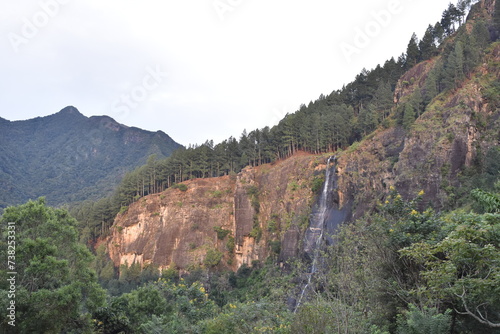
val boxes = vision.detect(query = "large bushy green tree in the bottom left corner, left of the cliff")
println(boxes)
[0,199,104,333]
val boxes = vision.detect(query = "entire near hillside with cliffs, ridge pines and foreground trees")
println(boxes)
[0,0,500,334]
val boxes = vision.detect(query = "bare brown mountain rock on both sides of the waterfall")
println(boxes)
[106,1,500,270]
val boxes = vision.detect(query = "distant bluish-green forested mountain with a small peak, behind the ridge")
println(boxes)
[0,106,181,208]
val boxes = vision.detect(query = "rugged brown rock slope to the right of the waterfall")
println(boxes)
[338,43,500,218]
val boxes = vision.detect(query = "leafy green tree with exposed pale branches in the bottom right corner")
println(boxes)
[401,213,500,327]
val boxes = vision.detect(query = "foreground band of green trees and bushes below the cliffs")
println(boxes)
[0,182,500,334]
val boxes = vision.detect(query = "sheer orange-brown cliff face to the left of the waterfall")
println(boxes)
[106,154,325,269]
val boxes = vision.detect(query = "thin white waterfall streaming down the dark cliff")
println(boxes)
[294,156,335,313]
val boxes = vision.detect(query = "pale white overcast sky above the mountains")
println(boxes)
[0,0,455,146]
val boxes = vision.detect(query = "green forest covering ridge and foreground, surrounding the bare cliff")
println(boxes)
[0,0,500,334]
